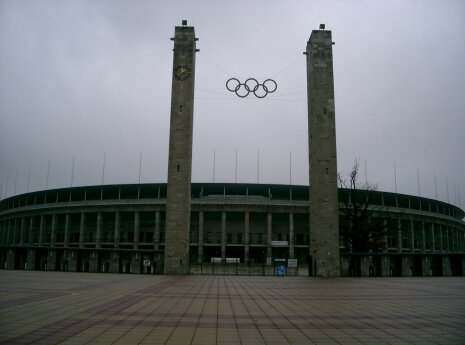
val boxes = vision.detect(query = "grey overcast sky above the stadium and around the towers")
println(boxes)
[0,0,465,208]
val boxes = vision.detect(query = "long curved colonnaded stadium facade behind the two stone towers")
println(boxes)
[0,183,465,276]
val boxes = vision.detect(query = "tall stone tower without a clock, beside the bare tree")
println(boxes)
[305,24,340,277]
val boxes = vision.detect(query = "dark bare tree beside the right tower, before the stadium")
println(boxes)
[338,159,389,253]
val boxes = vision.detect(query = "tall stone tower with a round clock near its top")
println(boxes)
[164,20,197,274]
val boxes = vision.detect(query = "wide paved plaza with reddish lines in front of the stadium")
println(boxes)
[0,271,465,345]
